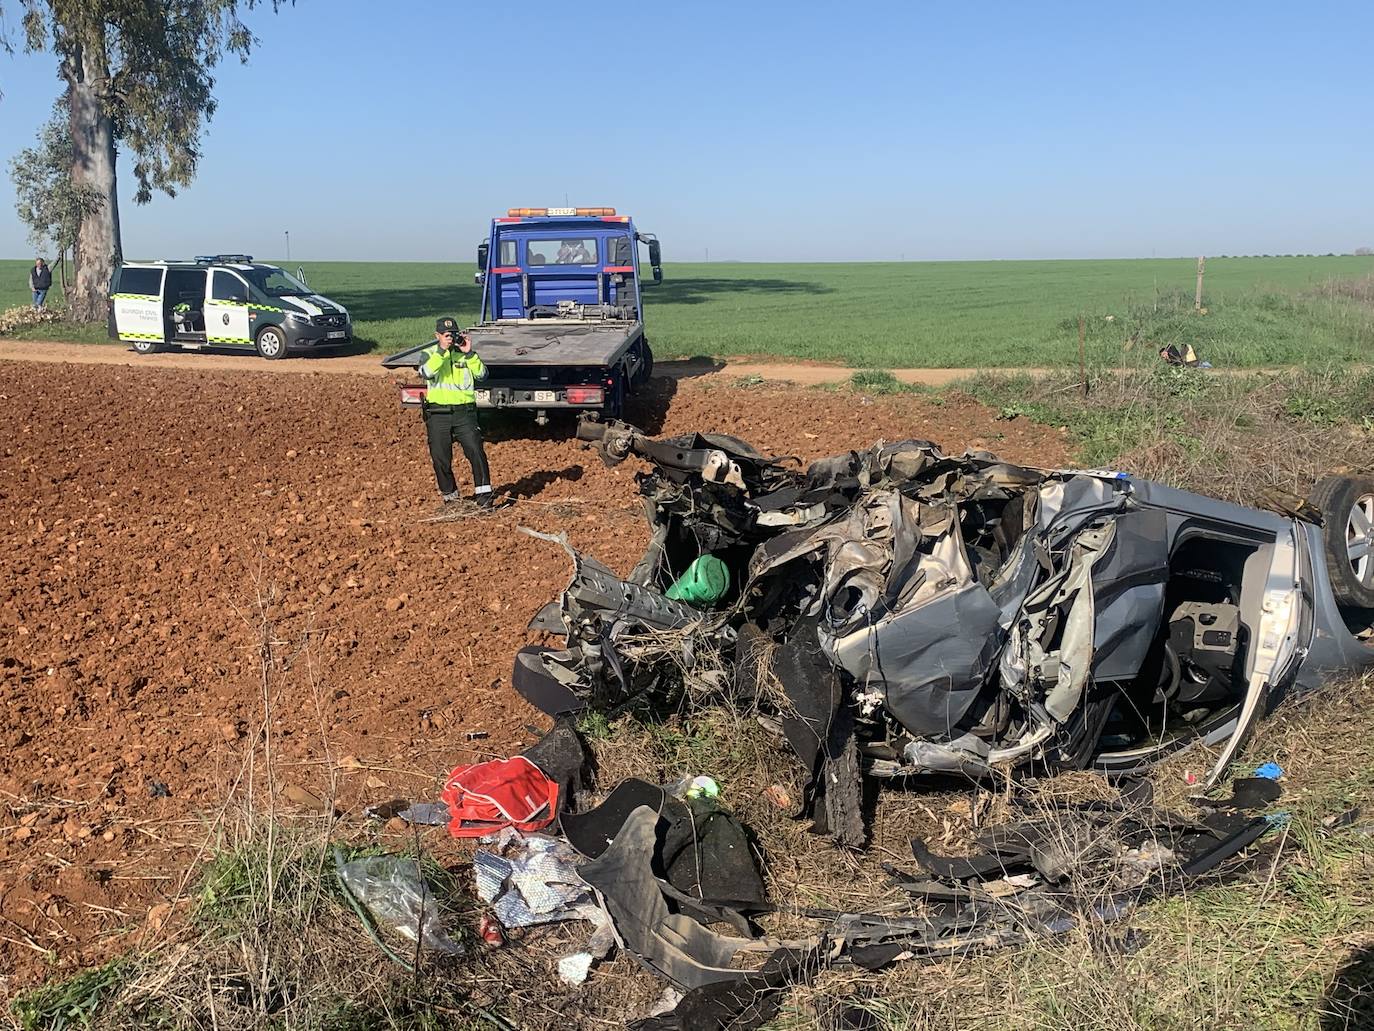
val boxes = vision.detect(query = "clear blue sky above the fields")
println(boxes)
[0,0,1374,263]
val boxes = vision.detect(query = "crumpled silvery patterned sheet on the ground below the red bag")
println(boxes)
[473,828,600,928]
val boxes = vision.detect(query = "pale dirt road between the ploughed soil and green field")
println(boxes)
[0,340,1011,386]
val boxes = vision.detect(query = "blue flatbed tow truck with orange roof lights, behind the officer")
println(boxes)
[382,208,664,426]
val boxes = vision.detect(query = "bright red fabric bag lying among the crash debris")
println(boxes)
[441,755,558,837]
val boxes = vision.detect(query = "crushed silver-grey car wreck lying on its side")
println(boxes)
[513,421,1374,839]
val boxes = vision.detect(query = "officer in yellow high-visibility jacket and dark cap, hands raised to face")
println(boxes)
[420,316,492,509]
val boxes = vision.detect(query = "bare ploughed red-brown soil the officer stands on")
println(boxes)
[0,362,1066,994]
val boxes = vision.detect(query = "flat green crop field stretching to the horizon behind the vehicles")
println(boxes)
[0,257,1374,368]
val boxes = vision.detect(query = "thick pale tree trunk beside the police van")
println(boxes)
[63,40,124,322]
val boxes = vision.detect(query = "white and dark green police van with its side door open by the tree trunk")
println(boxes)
[109,254,353,359]
